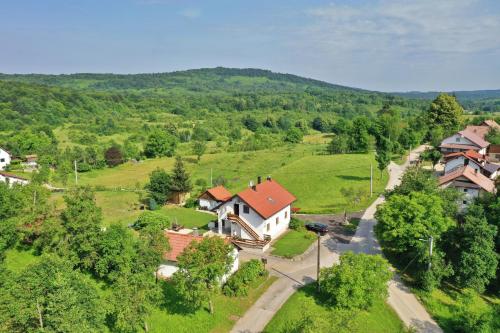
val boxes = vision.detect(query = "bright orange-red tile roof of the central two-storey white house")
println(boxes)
[237,179,297,219]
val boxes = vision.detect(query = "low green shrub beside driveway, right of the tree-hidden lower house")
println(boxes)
[223,259,268,296]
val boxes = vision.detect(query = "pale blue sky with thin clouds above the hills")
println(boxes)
[0,0,500,91]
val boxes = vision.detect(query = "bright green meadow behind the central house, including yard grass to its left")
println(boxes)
[65,136,387,226]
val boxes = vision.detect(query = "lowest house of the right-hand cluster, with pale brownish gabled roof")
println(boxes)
[439,166,495,209]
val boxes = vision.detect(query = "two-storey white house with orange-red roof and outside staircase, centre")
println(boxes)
[215,177,296,249]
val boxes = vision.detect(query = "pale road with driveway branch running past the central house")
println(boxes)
[231,147,442,333]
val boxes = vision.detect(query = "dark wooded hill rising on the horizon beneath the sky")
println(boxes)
[0,67,363,93]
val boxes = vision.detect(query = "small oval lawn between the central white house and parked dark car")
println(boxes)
[271,229,317,258]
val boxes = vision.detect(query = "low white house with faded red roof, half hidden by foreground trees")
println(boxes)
[157,229,239,282]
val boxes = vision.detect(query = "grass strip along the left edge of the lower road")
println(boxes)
[148,276,277,333]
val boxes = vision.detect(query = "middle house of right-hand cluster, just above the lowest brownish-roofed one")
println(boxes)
[444,150,500,179]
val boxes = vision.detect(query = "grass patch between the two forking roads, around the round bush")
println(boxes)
[264,284,404,333]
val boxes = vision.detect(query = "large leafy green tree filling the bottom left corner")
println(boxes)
[0,255,105,333]
